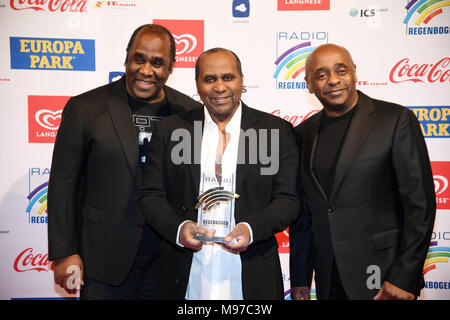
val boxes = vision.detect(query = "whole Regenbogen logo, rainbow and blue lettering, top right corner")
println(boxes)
[403,0,450,36]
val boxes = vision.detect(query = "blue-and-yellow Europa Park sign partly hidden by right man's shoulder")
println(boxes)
[408,106,450,138]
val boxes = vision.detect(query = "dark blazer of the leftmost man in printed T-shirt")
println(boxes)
[48,77,201,285]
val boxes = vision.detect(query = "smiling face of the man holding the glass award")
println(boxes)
[196,50,244,123]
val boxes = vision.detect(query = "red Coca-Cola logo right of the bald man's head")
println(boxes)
[389,57,450,83]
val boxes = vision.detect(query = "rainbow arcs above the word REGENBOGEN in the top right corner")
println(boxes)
[403,0,450,25]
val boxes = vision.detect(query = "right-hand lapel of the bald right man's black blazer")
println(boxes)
[331,91,376,199]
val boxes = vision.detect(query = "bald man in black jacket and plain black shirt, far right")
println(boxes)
[290,44,436,299]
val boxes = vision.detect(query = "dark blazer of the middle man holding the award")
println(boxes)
[139,104,298,299]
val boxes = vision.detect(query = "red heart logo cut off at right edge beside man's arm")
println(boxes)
[431,161,450,210]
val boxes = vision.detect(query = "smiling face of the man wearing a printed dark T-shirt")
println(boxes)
[125,30,173,102]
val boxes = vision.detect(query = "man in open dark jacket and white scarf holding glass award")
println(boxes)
[139,48,298,299]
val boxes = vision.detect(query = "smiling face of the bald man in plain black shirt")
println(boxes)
[305,44,358,117]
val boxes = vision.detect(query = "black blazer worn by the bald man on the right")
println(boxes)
[291,91,436,299]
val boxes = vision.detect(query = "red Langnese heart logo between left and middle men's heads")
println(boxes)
[153,19,205,68]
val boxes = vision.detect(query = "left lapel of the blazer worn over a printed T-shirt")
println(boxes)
[106,78,139,176]
